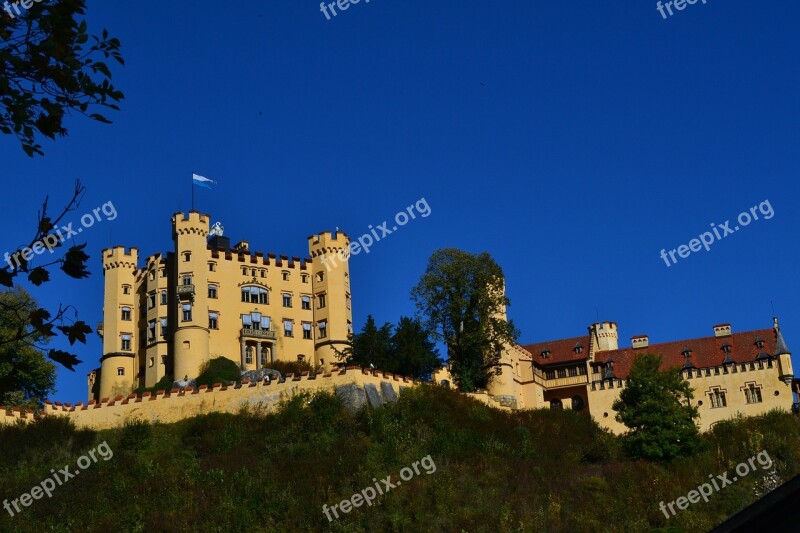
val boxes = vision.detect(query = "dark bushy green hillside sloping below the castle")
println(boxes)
[0,386,800,532]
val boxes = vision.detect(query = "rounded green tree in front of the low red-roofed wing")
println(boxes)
[612,353,700,462]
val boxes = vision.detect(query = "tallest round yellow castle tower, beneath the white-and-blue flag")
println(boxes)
[170,211,209,380]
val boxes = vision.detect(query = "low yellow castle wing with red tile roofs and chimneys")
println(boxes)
[466,318,794,433]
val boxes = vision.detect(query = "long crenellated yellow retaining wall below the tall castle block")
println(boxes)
[0,367,418,430]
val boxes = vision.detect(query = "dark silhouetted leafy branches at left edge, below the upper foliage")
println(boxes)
[0,181,92,371]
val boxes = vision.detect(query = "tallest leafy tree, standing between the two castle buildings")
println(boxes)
[411,248,519,392]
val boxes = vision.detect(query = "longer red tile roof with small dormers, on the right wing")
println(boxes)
[595,328,777,379]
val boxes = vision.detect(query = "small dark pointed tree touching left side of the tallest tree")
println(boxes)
[386,316,442,379]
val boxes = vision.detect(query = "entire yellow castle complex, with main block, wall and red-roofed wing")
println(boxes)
[0,211,788,433]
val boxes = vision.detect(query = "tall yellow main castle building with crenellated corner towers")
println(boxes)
[89,211,352,400]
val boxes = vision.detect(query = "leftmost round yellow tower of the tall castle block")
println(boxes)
[98,246,139,399]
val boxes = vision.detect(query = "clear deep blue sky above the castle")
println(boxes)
[0,0,800,401]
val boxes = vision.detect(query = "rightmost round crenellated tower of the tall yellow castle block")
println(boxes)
[308,231,353,370]
